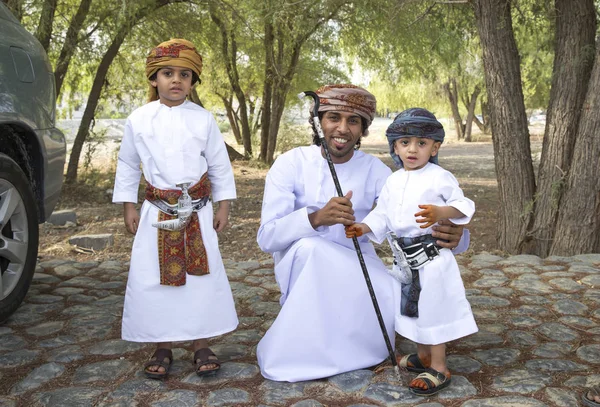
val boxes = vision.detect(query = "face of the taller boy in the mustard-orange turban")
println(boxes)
[150,66,192,107]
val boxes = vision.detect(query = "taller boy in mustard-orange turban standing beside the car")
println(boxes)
[113,39,238,379]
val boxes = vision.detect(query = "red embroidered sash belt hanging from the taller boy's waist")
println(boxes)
[145,173,211,286]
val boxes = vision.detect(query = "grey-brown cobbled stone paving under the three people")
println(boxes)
[0,253,600,407]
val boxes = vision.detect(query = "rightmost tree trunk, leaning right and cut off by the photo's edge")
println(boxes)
[550,39,600,256]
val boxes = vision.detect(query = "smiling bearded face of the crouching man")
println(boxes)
[321,111,363,164]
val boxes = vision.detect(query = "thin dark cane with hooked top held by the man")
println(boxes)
[298,91,400,377]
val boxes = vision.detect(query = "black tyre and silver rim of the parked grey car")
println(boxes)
[0,154,39,322]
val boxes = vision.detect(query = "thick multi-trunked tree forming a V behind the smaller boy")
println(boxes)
[473,0,600,256]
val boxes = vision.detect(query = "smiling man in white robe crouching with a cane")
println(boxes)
[257,85,462,382]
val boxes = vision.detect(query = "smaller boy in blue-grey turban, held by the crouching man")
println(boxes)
[346,108,477,396]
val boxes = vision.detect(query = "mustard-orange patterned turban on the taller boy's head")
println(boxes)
[146,38,202,100]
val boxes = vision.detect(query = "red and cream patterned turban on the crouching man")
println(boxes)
[310,84,377,135]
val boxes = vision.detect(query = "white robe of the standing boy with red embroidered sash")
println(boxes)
[113,101,238,342]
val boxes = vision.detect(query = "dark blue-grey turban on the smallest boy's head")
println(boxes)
[385,107,445,167]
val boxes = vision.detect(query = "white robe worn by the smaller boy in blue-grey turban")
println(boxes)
[363,163,477,345]
